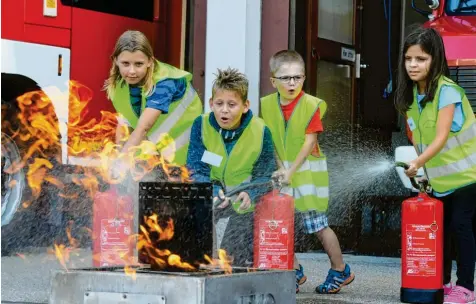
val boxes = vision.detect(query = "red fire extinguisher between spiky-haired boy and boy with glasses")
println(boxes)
[253,190,294,269]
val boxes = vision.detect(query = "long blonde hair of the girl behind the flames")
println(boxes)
[103,31,158,99]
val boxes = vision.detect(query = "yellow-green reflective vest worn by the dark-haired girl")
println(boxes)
[407,77,476,192]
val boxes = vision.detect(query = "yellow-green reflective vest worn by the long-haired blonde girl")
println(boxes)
[112,61,202,165]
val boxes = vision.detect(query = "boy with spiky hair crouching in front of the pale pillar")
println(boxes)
[187,68,277,266]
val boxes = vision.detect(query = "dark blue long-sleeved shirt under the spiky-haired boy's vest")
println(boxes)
[187,110,277,203]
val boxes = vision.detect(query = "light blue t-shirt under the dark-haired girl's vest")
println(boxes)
[417,85,465,197]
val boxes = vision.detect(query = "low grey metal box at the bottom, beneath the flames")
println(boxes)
[49,268,296,304]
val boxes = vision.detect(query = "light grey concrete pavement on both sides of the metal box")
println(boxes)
[1,250,468,304]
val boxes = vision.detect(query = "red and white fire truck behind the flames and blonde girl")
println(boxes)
[1,0,185,252]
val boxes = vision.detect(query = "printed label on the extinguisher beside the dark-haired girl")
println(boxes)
[405,225,436,277]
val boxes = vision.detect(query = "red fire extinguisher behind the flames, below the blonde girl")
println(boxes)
[92,186,135,267]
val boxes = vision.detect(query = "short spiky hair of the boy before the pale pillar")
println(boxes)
[212,68,248,102]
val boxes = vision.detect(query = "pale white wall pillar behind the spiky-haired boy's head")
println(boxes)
[204,0,261,113]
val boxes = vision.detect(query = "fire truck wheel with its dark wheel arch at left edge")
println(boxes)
[1,73,61,256]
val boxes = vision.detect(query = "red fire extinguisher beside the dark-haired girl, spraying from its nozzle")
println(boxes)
[397,163,444,304]
